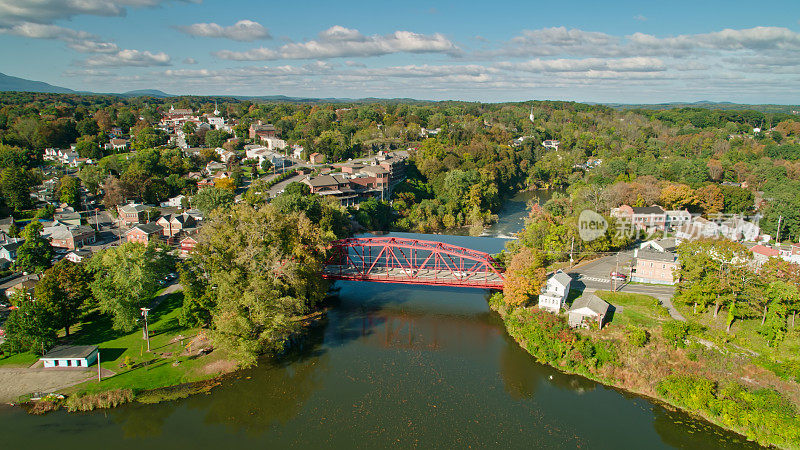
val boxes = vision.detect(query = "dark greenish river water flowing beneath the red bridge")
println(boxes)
[0,193,752,450]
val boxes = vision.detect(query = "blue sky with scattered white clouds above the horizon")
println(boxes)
[0,0,800,104]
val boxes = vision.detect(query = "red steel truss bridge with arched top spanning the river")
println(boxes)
[322,237,505,289]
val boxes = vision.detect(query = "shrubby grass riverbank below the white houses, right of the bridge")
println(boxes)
[491,292,800,448]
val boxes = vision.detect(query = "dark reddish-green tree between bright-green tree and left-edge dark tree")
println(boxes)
[35,259,91,336]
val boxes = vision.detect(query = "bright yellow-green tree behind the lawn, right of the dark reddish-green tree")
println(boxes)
[87,240,174,331]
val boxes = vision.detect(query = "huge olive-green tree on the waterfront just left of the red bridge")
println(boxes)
[193,203,327,366]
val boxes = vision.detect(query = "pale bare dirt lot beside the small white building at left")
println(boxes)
[0,366,97,403]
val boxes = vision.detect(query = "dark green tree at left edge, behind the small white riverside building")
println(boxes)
[3,291,57,355]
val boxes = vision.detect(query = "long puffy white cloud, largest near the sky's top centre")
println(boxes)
[215,25,461,61]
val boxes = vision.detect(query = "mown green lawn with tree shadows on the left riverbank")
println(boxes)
[0,292,237,410]
